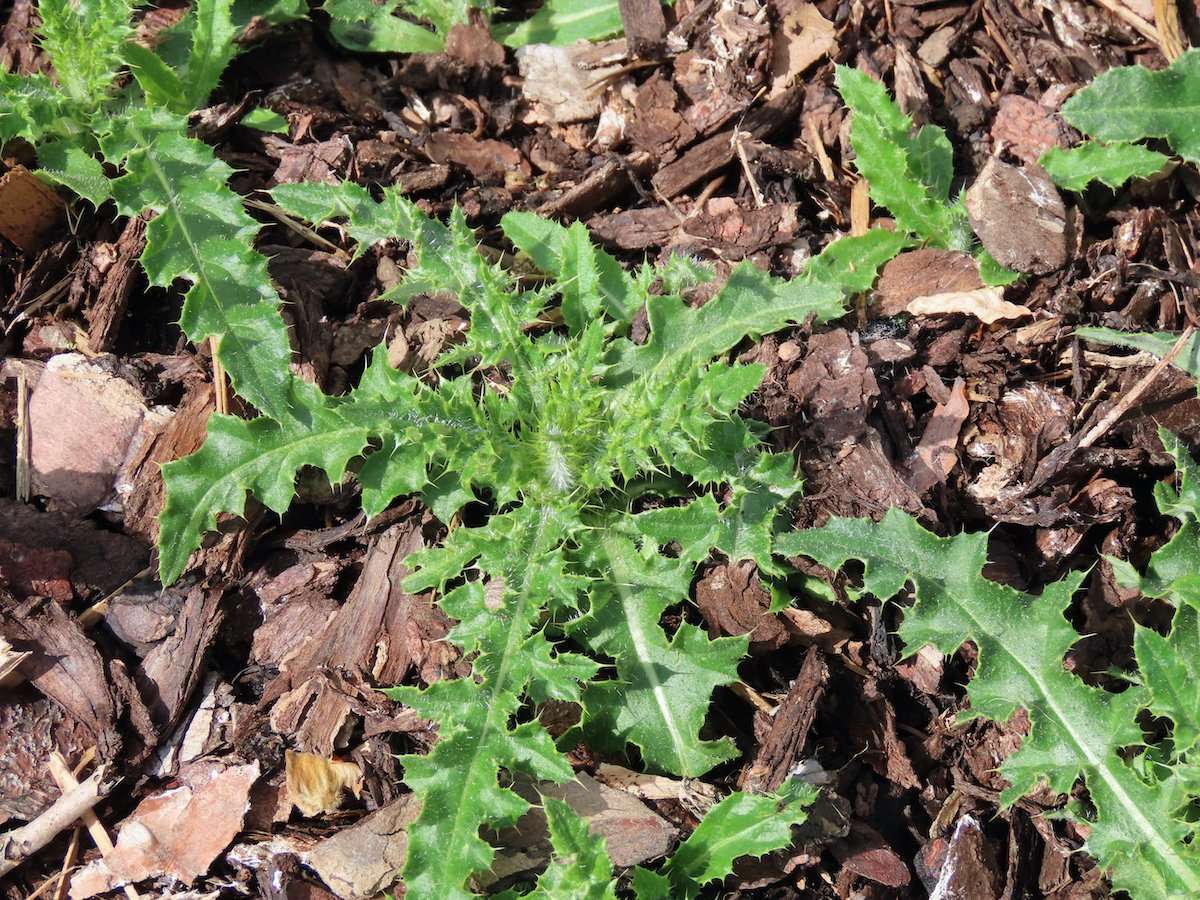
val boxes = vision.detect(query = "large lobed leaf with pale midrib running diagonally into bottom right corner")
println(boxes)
[776,509,1200,898]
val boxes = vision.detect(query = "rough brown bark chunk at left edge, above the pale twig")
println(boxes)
[0,596,121,761]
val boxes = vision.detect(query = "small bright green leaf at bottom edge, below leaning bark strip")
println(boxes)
[662,785,816,900]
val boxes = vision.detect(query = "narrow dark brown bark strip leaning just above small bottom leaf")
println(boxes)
[738,646,829,793]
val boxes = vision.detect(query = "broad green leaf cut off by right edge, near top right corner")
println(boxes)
[1062,49,1200,162]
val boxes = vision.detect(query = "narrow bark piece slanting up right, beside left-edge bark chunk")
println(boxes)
[134,586,223,733]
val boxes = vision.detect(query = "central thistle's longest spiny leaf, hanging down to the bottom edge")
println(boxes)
[388,505,594,898]
